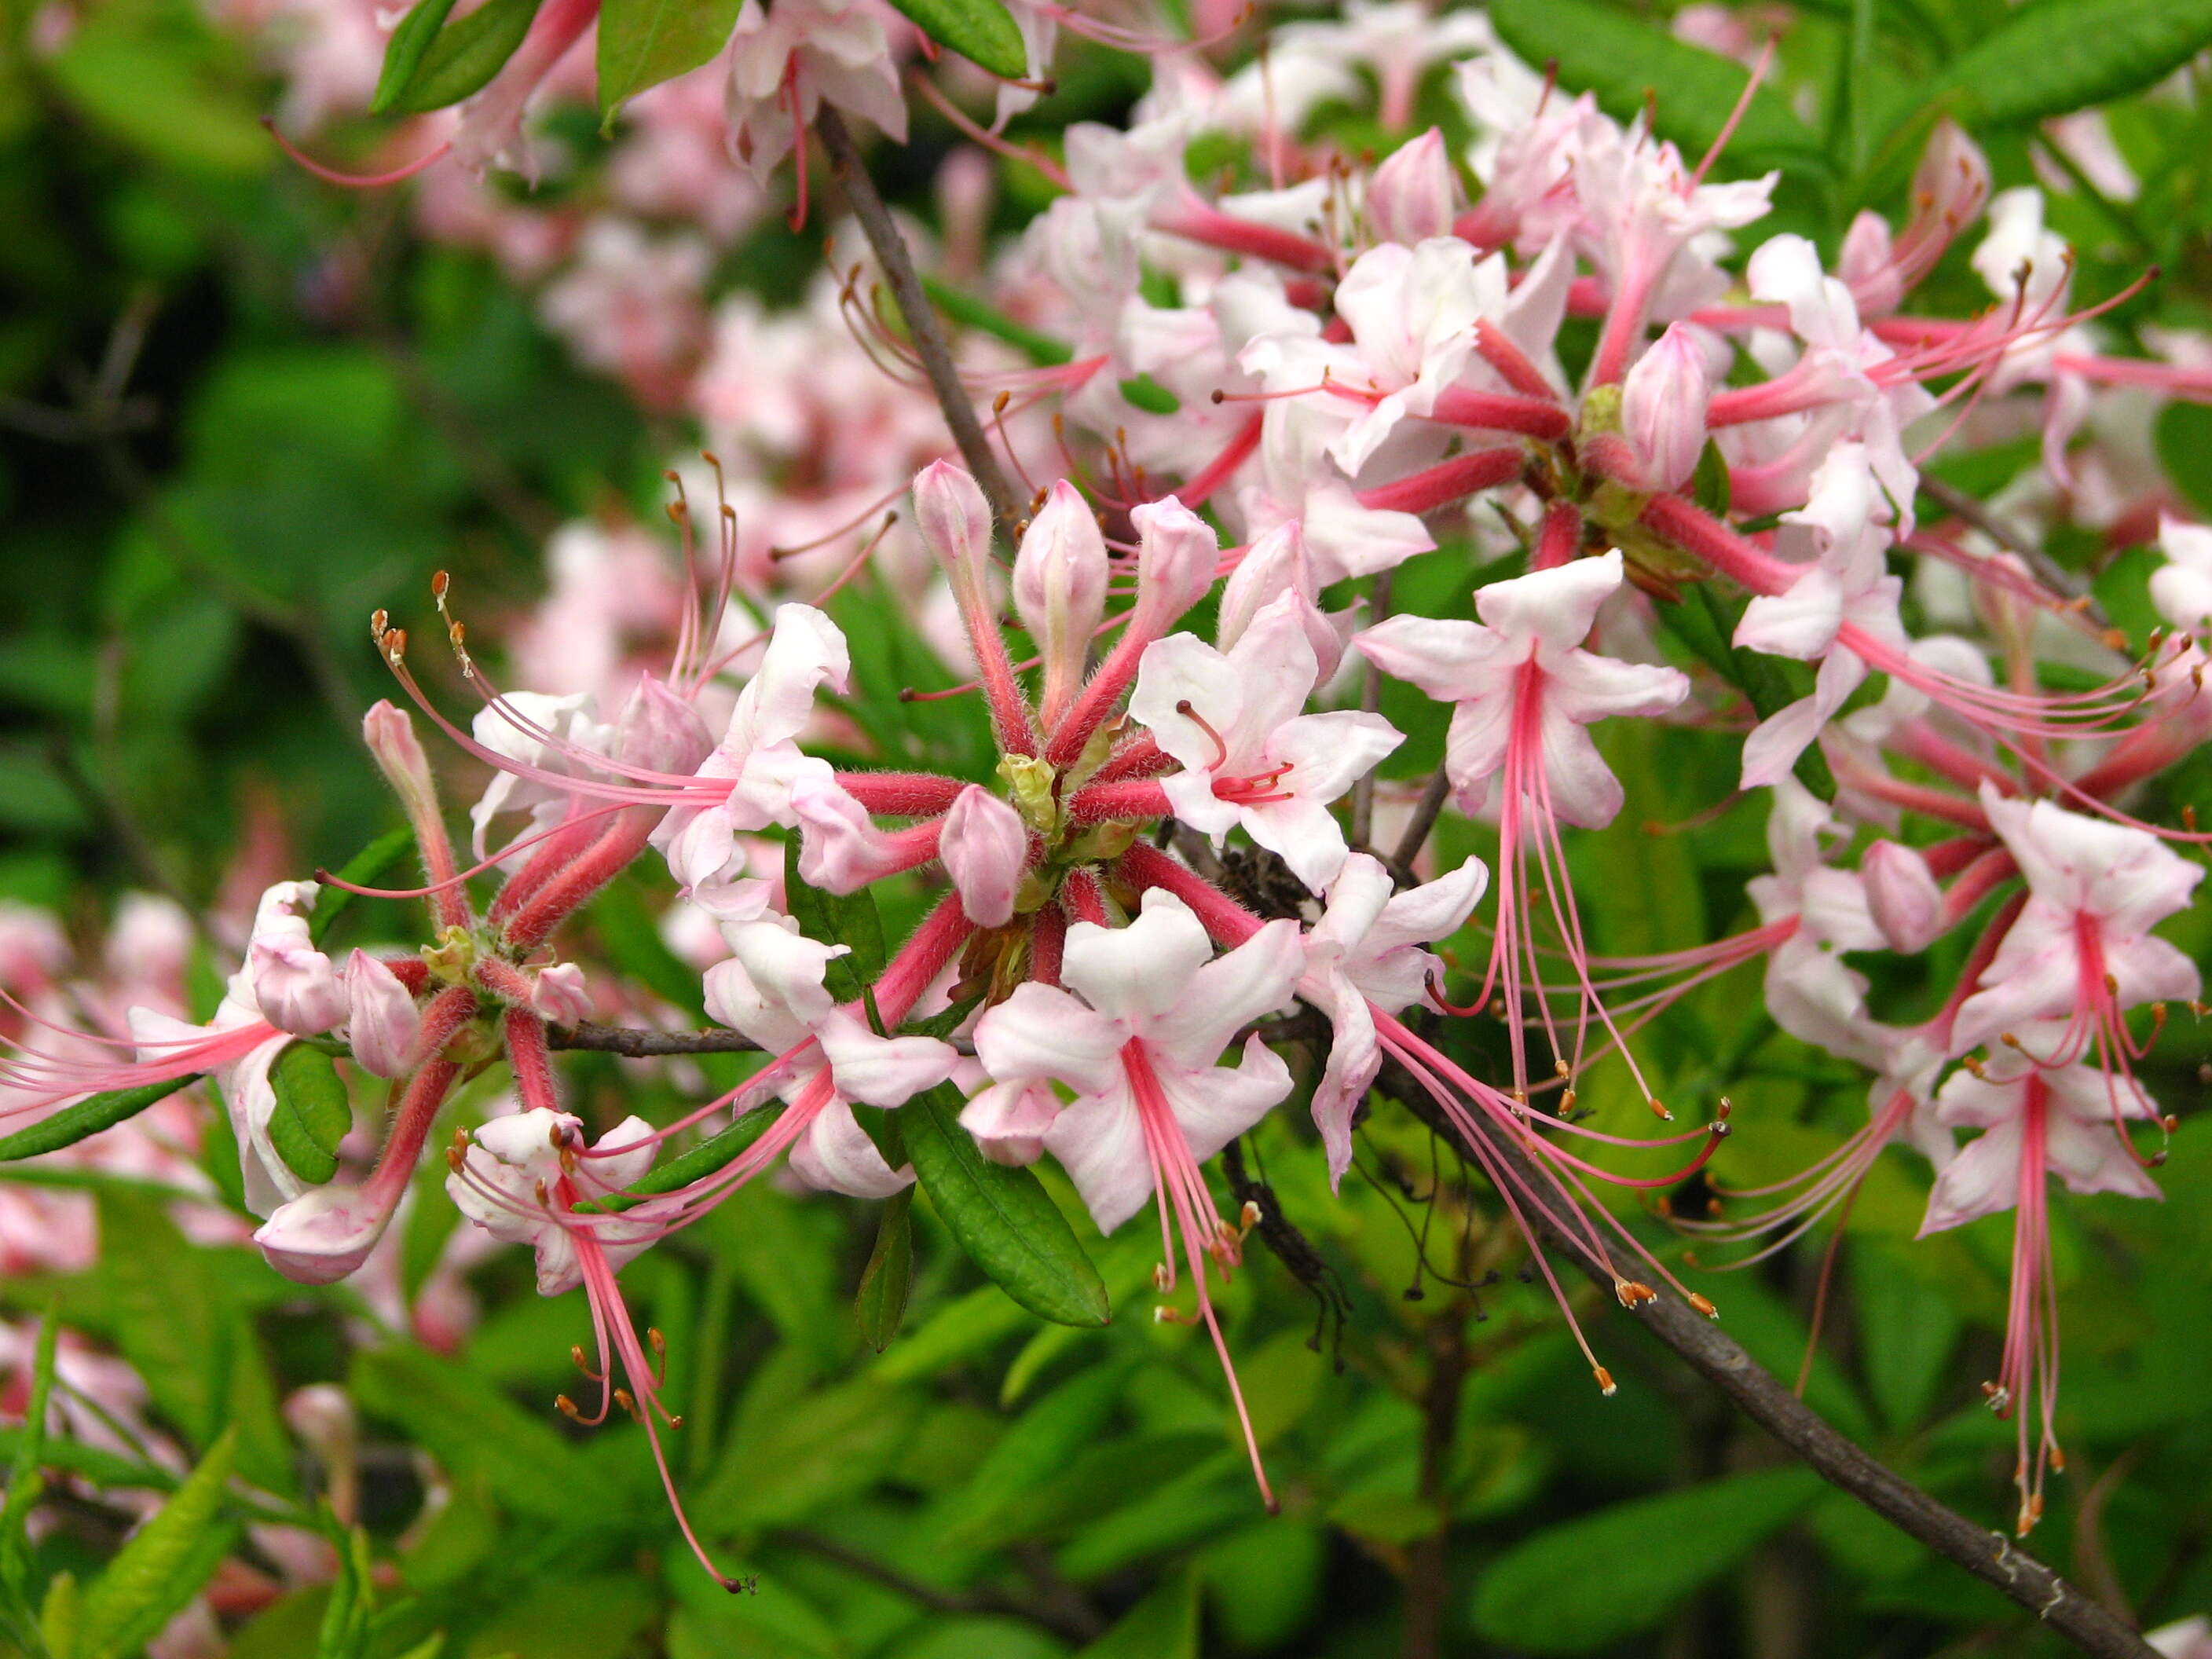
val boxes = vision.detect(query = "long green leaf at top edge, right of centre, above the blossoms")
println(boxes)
[1489,0,1829,174]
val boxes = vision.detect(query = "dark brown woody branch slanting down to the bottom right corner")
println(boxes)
[1376,1066,2157,1659]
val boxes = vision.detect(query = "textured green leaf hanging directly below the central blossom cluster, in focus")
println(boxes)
[898,1084,1112,1325]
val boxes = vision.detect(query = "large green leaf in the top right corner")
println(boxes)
[1916,0,2212,124]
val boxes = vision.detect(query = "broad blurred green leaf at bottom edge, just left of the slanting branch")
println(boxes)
[1473,1469,1821,1653]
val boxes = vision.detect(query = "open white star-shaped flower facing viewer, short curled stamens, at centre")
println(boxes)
[1128,593,1404,892]
